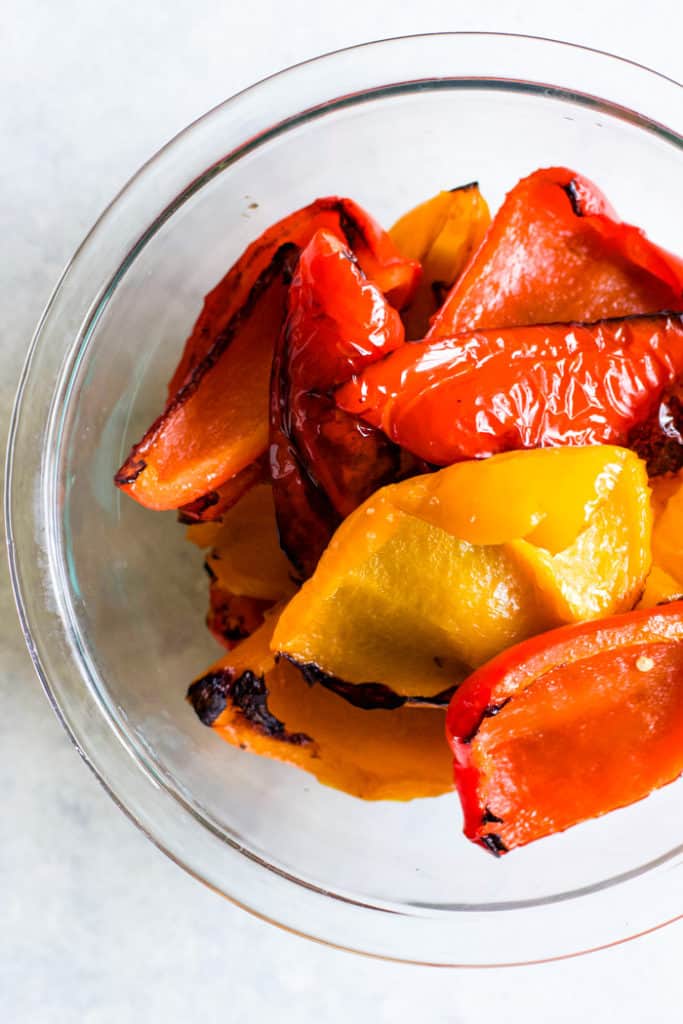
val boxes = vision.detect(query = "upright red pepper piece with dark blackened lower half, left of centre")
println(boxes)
[270,230,403,575]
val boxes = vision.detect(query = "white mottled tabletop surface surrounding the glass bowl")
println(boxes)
[0,0,683,1024]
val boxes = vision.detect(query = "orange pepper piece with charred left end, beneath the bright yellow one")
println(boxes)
[187,612,453,800]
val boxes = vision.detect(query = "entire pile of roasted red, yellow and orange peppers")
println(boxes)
[116,167,683,854]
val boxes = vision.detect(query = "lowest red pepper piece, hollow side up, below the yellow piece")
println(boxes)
[446,601,683,855]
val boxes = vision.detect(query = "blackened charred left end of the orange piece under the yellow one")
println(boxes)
[186,669,313,746]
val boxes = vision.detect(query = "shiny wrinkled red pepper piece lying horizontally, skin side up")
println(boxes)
[337,313,683,465]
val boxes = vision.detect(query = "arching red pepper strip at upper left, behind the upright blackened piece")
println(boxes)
[169,196,420,399]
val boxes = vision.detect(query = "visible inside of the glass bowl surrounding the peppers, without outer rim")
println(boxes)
[57,81,683,911]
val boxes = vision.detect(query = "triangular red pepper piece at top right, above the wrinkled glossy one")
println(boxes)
[428,167,683,340]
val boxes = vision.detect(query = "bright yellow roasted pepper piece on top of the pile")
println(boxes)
[272,446,651,707]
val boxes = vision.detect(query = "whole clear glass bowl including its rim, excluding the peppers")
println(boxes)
[7,34,683,965]
